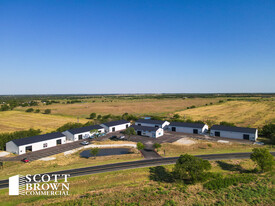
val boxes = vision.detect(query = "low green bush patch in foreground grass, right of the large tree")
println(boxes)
[203,174,257,190]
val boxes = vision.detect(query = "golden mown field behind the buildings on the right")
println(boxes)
[177,101,275,127]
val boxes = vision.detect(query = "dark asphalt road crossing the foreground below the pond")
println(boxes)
[0,152,275,189]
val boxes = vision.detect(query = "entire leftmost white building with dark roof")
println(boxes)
[6,132,66,155]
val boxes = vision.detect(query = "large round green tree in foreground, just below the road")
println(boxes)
[173,154,211,183]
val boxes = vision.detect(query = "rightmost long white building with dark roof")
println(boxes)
[210,125,258,141]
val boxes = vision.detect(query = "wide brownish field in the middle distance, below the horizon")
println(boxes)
[18,98,224,118]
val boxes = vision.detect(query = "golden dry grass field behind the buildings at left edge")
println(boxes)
[0,111,88,133]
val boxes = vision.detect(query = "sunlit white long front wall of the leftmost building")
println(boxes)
[15,136,66,154]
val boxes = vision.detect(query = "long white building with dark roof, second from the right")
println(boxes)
[168,122,208,134]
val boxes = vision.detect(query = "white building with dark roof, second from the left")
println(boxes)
[62,125,104,141]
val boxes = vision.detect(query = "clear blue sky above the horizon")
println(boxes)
[0,0,275,94]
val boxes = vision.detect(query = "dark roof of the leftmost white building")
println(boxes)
[12,132,65,146]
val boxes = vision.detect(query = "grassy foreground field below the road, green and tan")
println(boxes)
[0,160,274,206]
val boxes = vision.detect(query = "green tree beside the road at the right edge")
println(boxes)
[250,148,275,172]
